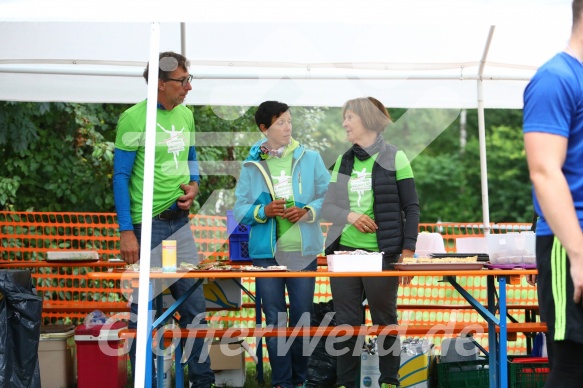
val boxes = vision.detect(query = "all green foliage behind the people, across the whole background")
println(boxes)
[0,102,532,222]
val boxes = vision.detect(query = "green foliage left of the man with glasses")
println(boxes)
[0,102,124,211]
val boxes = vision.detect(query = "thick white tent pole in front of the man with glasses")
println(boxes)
[134,23,160,387]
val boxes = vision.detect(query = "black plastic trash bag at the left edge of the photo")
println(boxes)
[0,270,42,388]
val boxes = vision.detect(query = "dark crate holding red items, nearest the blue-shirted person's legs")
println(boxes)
[508,357,550,388]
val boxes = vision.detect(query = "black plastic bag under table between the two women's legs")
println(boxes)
[306,300,336,387]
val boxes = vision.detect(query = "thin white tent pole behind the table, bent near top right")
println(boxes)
[478,26,496,235]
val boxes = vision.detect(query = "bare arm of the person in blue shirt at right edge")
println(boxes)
[524,132,583,302]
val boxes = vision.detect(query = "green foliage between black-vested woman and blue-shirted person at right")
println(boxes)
[411,110,532,222]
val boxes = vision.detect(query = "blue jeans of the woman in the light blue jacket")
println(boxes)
[253,252,317,388]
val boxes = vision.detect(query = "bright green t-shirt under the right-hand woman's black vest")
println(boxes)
[332,150,413,252]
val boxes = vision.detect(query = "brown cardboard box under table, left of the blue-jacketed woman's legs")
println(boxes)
[209,342,247,387]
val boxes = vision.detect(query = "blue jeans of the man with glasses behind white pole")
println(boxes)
[128,217,215,388]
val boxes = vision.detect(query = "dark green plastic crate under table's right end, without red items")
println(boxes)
[437,359,490,388]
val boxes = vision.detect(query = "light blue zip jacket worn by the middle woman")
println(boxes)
[233,139,330,259]
